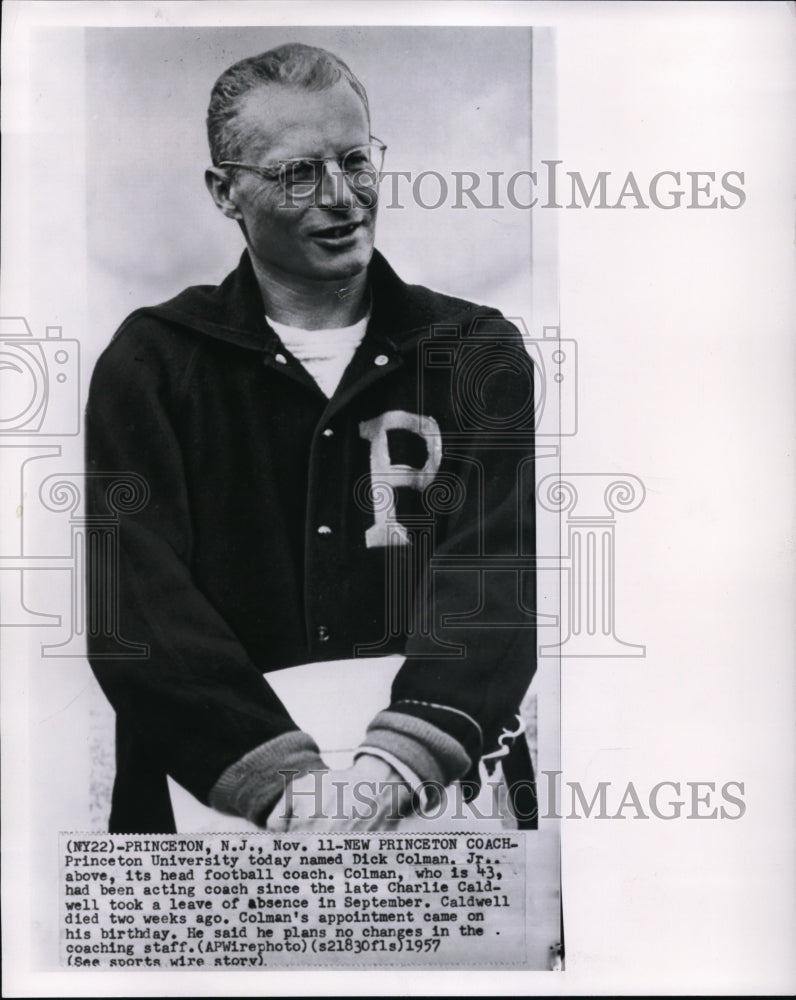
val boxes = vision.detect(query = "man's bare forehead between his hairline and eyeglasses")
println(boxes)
[237,80,369,157]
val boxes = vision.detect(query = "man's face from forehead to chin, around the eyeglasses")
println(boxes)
[231,81,376,281]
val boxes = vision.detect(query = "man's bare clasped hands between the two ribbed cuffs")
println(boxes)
[266,754,412,833]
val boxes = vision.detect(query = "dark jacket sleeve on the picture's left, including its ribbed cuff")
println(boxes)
[86,321,322,822]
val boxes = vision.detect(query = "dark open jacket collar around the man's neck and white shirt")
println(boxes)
[141,250,477,350]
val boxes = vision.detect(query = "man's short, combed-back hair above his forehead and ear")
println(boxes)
[207,42,370,166]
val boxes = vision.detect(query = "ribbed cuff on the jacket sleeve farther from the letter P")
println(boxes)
[209,730,326,825]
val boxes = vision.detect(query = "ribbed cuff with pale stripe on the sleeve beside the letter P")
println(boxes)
[364,711,470,787]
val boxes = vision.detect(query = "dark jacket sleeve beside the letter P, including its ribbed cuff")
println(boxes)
[365,314,536,785]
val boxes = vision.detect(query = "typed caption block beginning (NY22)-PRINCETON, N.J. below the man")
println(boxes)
[60,833,526,970]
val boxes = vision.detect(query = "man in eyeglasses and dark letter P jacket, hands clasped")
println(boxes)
[87,45,534,832]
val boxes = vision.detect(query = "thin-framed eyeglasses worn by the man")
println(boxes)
[218,135,387,198]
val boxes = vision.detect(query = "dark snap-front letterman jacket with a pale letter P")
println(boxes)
[86,246,535,832]
